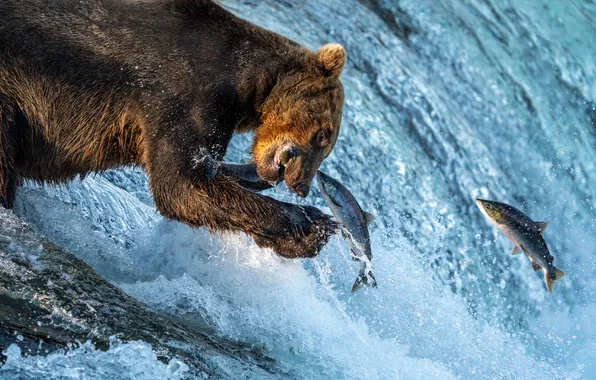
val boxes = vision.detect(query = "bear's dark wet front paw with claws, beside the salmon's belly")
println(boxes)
[255,204,338,258]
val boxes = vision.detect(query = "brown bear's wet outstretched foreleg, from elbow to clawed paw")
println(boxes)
[148,143,337,258]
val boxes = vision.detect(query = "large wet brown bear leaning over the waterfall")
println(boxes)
[0,0,346,257]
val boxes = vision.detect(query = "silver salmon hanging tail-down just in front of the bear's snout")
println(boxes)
[317,170,377,292]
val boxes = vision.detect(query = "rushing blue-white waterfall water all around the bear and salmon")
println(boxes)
[2,0,596,379]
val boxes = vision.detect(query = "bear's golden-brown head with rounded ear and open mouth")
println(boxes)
[252,44,346,197]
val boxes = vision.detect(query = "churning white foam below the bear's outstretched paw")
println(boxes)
[120,227,559,379]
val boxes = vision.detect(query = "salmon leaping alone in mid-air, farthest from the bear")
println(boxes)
[476,199,565,293]
